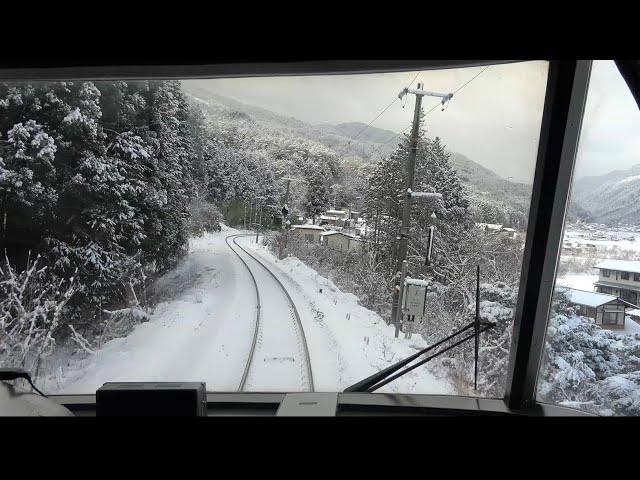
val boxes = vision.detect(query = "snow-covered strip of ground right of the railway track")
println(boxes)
[239,239,453,394]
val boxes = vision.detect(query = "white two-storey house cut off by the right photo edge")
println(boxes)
[594,260,640,308]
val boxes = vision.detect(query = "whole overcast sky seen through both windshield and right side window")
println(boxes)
[184,61,640,183]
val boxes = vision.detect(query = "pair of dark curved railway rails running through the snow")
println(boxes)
[225,234,314,392]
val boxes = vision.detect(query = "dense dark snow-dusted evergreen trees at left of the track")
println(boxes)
[0,81,206,376]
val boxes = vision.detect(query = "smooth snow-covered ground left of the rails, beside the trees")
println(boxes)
[49,230,256,394]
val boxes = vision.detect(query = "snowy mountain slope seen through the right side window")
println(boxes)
[569,164,640,225]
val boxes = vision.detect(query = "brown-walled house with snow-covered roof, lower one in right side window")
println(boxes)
[563,288,635,330]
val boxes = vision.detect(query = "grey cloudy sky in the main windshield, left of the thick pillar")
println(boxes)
[184,61,560,182]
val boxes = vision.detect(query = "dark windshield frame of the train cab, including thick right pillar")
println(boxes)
[0,60,592,415]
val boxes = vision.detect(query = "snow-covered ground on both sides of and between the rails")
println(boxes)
[46,227,453,394]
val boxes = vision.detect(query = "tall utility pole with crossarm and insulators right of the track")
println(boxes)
[391,83,453,338]
